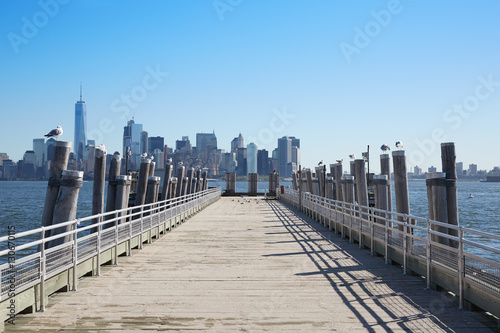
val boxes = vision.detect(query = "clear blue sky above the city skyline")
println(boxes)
[0,0,500,171]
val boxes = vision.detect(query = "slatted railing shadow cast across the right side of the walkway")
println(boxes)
[268,201,480,332]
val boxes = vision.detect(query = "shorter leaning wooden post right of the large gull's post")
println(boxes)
[47,170,83,248]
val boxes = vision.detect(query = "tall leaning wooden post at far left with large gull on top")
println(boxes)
[42,141,71,237]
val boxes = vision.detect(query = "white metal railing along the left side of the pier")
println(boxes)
[0,188,221,311]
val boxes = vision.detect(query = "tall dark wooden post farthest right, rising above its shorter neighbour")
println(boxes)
[441,142,459,248]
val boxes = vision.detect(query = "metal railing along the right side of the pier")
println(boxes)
[281,189,500,316]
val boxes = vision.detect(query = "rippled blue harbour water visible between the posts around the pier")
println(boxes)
[0,180,500,261]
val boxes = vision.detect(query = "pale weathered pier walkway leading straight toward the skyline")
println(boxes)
[6,198,490,332]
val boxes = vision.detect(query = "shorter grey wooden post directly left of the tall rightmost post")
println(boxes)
[425,172,450,245]
